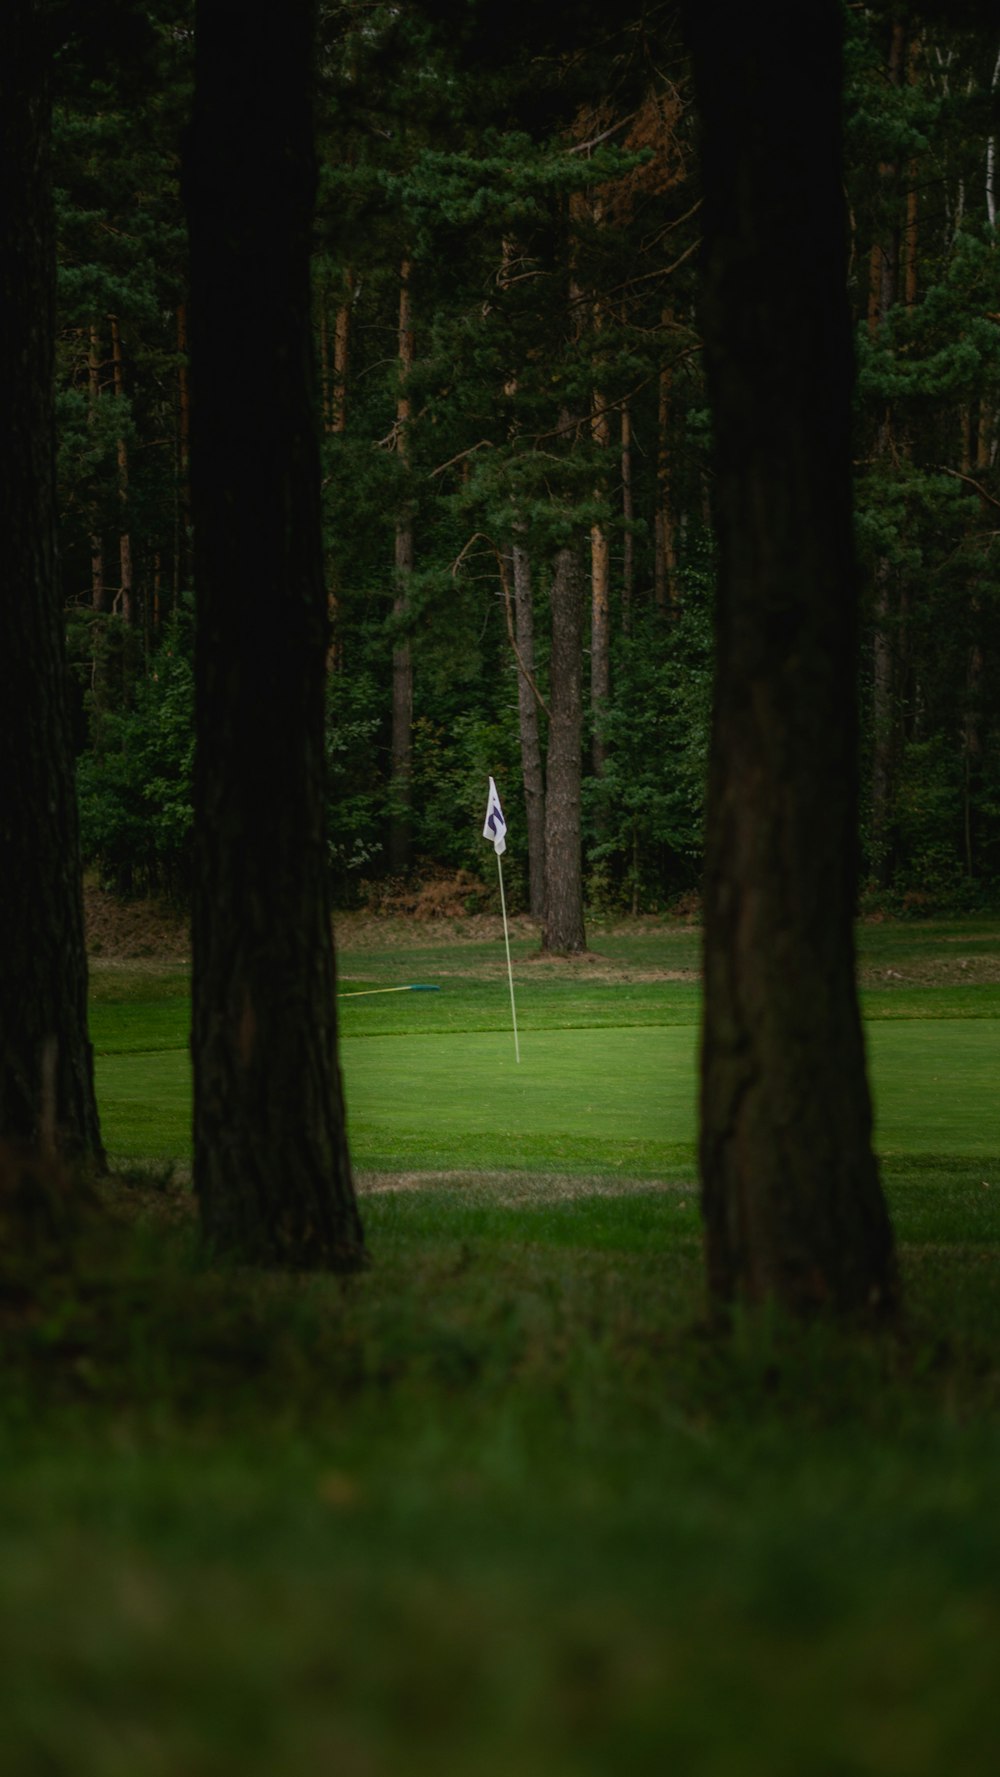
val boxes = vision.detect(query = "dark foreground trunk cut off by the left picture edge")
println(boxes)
[0,10,105,1166]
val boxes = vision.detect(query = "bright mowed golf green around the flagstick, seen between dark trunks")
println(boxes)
[94,952,1000,1178]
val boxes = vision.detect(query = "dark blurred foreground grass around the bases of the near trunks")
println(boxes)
[0,1162,1000,1777]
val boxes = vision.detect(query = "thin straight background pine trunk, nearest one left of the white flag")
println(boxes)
[389,259,414,873]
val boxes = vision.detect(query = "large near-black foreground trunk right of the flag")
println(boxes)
[689,0,895,1313]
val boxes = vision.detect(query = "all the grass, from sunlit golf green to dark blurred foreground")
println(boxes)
[0,924,1000,1777]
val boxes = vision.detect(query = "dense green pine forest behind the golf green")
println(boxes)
[55,0,1000,912]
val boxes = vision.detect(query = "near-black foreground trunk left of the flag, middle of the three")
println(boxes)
[187,0,364,1271]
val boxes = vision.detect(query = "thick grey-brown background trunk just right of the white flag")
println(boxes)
[542,542,586,952]
